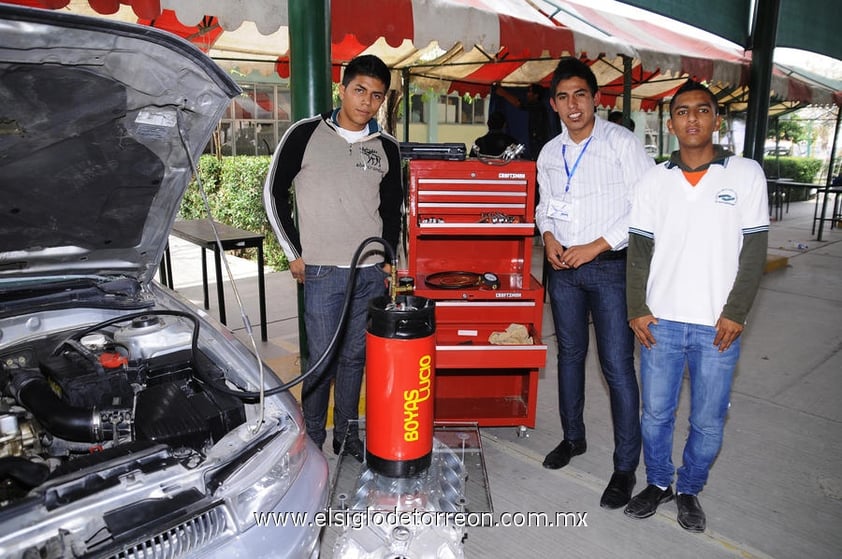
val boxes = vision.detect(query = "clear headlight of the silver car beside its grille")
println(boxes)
[219,423,307,532]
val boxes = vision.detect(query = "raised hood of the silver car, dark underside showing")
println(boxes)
[0,5,240,283]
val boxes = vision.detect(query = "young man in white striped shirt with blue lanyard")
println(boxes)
[535,57,654,509]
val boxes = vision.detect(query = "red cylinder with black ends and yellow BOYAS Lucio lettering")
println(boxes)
[365,295,436,477]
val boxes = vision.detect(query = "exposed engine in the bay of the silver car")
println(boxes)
[0,313,245,507]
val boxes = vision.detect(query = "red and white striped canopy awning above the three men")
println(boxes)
[10,0,842,112]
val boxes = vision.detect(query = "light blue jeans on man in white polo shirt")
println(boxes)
[640,319,740,495]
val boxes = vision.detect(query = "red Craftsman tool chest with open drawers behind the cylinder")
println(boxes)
[403,160,547,428]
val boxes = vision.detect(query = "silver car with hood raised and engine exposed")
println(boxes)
[0,6,328,559]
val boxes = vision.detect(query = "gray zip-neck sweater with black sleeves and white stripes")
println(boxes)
[263,109,403,266]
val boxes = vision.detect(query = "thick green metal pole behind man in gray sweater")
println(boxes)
[287,0,331,364]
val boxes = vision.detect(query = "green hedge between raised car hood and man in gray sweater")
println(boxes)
[178,155,289,270]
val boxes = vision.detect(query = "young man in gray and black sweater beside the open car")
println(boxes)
[264,55,403,461]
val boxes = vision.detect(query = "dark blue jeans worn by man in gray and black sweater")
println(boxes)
[301,265,388,447]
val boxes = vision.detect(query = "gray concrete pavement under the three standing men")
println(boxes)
[161,196,842,559]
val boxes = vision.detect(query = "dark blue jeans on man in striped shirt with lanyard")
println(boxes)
[547,260,640,472]
